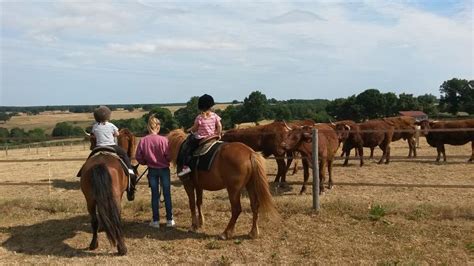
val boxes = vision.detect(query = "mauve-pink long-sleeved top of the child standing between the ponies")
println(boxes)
[135,134,170,168]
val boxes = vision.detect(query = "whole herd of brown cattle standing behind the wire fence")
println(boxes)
[222,116,474,193]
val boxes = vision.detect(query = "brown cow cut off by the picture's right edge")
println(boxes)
[419,119,474,162]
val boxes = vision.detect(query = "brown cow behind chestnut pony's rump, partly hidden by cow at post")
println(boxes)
[221,120,314,186]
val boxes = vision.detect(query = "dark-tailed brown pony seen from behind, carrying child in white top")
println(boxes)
[81,153,128,255]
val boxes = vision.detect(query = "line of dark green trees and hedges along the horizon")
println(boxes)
[0,78,474,143]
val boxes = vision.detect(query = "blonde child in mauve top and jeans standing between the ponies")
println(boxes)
[135,115,175,228]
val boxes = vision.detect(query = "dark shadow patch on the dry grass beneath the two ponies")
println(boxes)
[0,215,212,258]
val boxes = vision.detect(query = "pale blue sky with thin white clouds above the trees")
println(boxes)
[0,0,474,106]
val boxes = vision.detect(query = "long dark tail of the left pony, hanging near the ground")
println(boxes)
[91,164,122,246]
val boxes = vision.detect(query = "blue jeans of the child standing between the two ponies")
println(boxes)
[148,167,173,221]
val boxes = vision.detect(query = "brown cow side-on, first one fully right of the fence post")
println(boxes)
[336,120,394,166]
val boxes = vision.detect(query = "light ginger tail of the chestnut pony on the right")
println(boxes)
[251,152,280,219]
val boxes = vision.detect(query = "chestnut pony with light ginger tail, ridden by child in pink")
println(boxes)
[168,129,278,239]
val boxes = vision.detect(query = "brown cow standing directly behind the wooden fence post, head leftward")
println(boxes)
[282,124,339,194]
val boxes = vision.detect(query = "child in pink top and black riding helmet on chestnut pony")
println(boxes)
[178,94,222,177]
